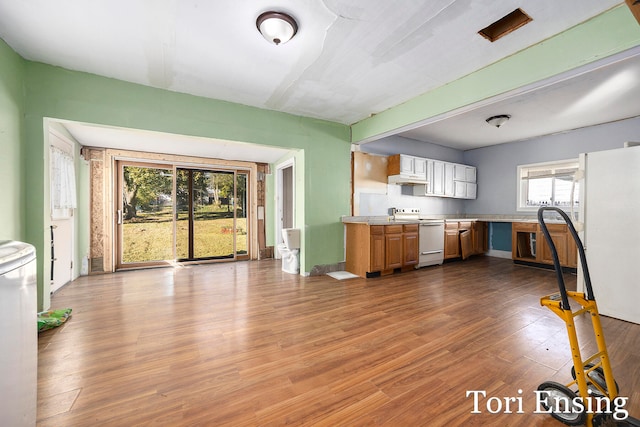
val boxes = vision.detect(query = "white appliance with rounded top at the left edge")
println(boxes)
[0,241,38,427]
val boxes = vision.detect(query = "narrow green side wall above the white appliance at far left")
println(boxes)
[0,39,26,240]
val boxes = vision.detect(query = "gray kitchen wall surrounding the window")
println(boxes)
[463,117,640,215]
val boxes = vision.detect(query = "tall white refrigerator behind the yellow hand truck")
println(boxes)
[576,146,640,324]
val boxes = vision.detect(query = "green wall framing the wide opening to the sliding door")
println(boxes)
[18,62,350,307]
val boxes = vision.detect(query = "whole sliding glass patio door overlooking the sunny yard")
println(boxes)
[117,162,249,268]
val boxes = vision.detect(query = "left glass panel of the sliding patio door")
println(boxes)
[118,164,173,264]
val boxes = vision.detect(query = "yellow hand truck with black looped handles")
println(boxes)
[536,206,640,427]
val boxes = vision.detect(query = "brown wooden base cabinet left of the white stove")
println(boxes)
[345,223,419,277]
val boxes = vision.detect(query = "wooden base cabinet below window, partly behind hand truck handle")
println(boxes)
[511,222,578,269]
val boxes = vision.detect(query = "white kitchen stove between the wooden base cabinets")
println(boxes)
[392,208,444,268]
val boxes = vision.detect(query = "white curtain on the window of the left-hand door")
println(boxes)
[50,146,76,214]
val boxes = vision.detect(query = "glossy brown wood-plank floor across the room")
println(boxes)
[38,257,640,427]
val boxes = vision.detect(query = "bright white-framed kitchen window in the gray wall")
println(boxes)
[518,159,580,211]
